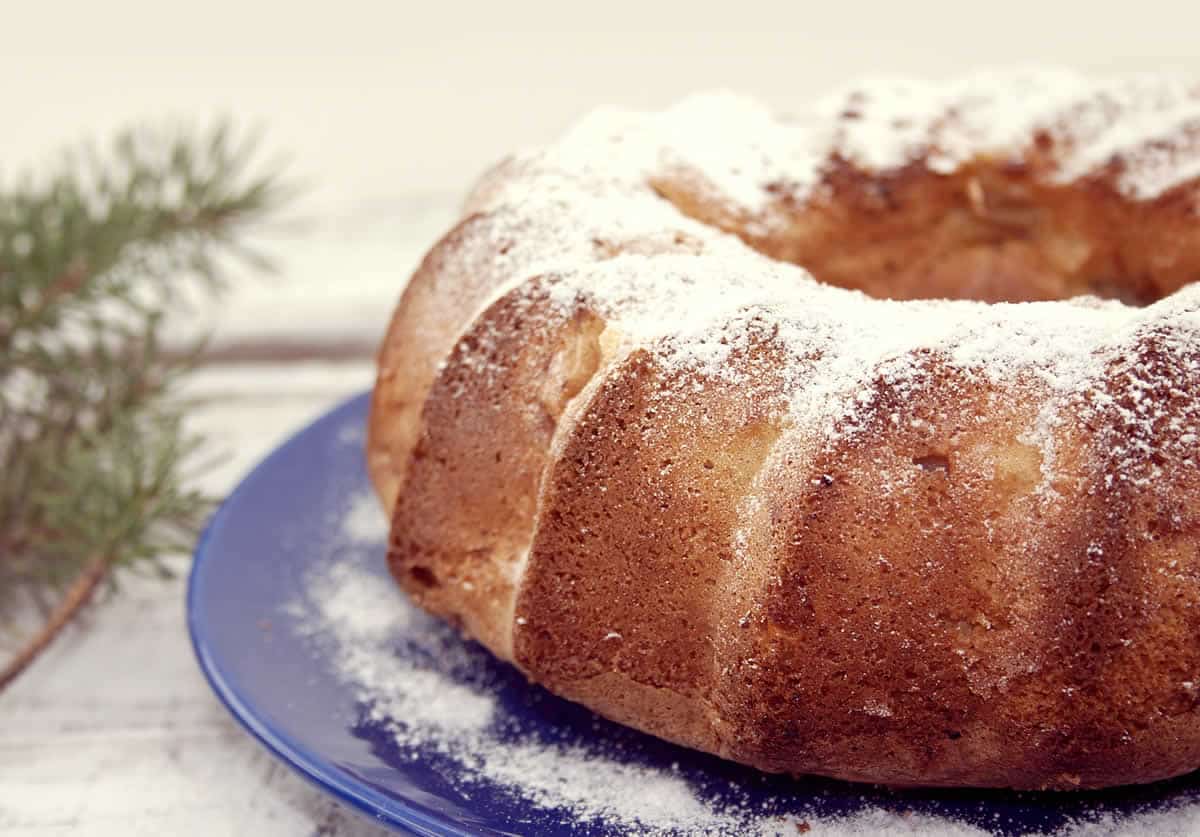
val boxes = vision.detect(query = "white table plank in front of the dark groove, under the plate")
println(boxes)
[0,362,386,837]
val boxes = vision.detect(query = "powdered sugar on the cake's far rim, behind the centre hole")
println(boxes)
[753,70,1200,200]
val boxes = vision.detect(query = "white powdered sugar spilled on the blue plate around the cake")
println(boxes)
[288,486,1200,837]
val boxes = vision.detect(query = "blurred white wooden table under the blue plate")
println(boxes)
[0,201,441,837]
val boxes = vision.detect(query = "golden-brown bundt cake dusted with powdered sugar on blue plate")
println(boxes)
[368,72,1200,789]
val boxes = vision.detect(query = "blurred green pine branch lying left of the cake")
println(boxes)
[0,125,286,690]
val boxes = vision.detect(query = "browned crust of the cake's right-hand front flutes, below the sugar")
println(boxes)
[722,352,1200,789]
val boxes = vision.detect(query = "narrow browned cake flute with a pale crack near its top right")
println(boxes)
[389,281,604,657]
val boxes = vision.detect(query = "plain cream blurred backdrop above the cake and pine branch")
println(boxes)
[7,0,1200,217]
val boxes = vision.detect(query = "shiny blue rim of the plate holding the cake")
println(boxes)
[186,390,480,837]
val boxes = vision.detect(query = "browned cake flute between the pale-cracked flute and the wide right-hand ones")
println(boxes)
[514,328,801,752]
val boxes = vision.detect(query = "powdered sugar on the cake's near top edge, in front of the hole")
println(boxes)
[476,232,1200,501]
